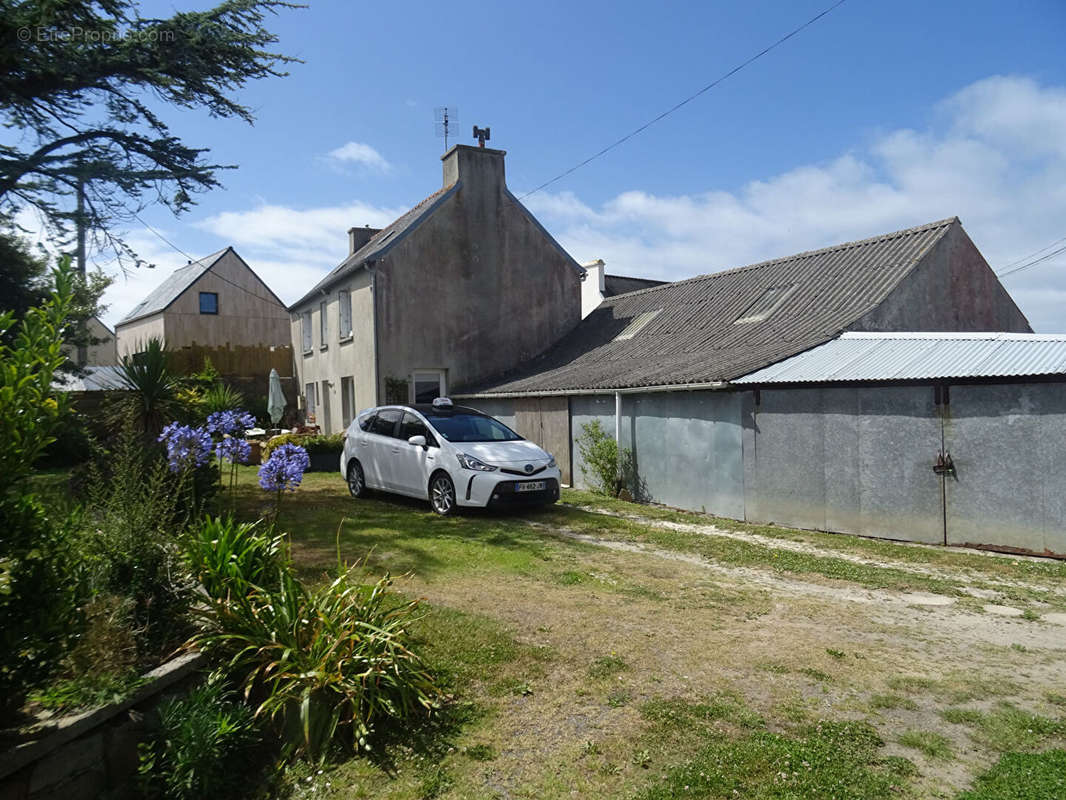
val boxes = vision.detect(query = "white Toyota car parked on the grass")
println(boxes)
[340,397,561,515]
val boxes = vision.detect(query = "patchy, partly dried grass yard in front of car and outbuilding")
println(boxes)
[229,468,1066,800]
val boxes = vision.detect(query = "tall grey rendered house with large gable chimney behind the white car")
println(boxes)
[289,145,584,432]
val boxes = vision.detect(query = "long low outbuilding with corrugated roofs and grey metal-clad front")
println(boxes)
[453,219,1066,555]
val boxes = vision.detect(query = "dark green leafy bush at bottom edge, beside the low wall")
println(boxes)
[140,683,260,800]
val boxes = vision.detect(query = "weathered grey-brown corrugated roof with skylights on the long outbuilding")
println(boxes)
[455,218,958,396]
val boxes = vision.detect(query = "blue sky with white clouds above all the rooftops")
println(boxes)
[18,0,1066,332]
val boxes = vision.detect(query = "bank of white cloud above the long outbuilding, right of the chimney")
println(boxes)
[528,77,1066,331]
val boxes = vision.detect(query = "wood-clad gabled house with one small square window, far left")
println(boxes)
[115,247,290,356]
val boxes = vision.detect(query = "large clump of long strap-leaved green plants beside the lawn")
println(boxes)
[187,521,442,759]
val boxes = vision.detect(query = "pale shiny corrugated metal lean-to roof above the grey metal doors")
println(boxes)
[733,333,1066,384]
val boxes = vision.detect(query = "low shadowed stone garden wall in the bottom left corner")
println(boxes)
[0,653,205,800]
